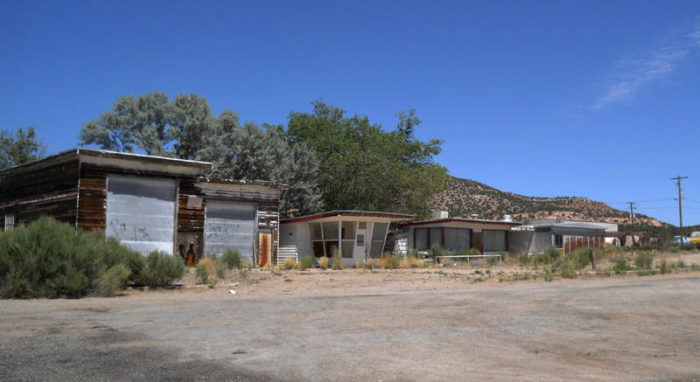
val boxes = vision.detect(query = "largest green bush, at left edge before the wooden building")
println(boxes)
[0,217,143,298]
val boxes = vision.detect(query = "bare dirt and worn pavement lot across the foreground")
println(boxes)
[0,255,700,381]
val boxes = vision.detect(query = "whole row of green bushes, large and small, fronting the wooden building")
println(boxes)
[0,217,185,298]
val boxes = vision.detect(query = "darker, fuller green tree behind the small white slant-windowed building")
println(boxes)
[286,101,448,215]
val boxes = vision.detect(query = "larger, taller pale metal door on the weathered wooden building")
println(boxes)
[105,175,177,254]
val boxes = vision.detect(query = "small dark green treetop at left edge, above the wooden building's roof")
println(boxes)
[0,127,43,169]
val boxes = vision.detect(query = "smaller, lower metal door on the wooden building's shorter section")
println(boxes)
[204,200,257,258]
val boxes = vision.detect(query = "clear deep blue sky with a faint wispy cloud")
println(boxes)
[0,0,700,224]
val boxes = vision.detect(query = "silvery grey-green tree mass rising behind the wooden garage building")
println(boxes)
[80,91,320,213]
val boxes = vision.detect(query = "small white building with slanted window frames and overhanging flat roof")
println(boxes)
[277,210,415,266]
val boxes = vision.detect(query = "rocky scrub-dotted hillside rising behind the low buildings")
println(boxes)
[430,178,663,227]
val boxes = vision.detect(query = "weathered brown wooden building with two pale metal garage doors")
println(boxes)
[0,149,280,265]
